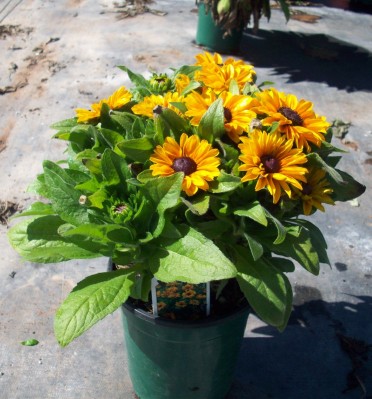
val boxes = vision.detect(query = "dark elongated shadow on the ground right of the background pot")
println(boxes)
[240,30,372,92]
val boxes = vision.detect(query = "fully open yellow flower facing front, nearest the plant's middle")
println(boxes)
[150,133,220,196]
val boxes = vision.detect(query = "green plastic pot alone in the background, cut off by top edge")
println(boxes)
[196,4,243,54]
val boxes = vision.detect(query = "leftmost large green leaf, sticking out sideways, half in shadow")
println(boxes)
[8,215,105,263]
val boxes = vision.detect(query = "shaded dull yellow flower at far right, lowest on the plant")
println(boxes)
[295,169,334,215]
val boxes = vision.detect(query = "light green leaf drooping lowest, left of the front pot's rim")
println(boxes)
[54,268,137,346]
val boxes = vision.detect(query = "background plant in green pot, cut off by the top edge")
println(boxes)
[196,0,290,53]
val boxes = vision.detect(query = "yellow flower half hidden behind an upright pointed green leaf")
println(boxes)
[220,91,256,143]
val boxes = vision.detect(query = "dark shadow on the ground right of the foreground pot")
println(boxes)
[227,287,372,399]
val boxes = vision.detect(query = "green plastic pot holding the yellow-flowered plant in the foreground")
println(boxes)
[122,303,249,399]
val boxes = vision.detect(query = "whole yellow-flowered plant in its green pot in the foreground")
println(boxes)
[9,53,365,399]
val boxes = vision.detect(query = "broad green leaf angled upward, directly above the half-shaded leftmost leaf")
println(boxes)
[43,161,89,225]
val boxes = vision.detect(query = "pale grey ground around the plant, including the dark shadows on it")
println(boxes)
[0,0,372,399]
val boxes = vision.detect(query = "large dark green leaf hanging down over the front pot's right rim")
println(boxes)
[235,247,293,329]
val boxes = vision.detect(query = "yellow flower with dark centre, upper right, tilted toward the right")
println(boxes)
[252,89,330,152]
